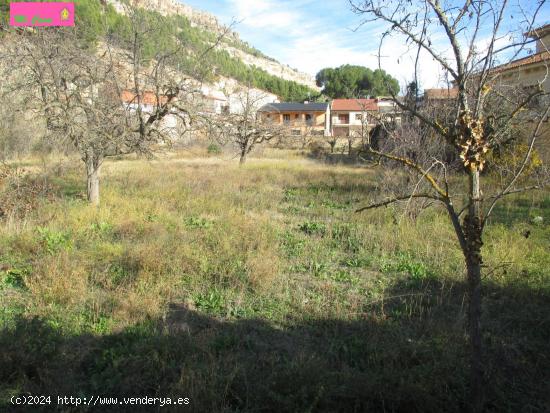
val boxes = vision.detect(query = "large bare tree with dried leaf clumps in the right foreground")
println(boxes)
[350,0,549,412]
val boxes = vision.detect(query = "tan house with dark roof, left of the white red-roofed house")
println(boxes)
[258,101,330,136]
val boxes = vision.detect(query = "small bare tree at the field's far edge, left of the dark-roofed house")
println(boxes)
[211,86,287,165]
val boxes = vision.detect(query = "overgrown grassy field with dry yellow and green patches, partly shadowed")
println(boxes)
[0,152,550,412]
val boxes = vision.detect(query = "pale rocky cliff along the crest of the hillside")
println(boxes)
[107,0,320,90]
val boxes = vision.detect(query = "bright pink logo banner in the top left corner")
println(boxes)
[10,2,74,27]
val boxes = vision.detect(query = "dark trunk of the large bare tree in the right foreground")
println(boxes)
[464,169,483,413]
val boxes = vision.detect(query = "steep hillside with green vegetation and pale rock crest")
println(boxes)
[0,0,319,101]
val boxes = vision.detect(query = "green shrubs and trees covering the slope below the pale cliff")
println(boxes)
[0,0,319,101]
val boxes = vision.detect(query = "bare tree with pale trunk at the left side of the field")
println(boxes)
[2,28,178,205]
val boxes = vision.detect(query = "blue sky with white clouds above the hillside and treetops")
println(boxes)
[180,0,550,88]
